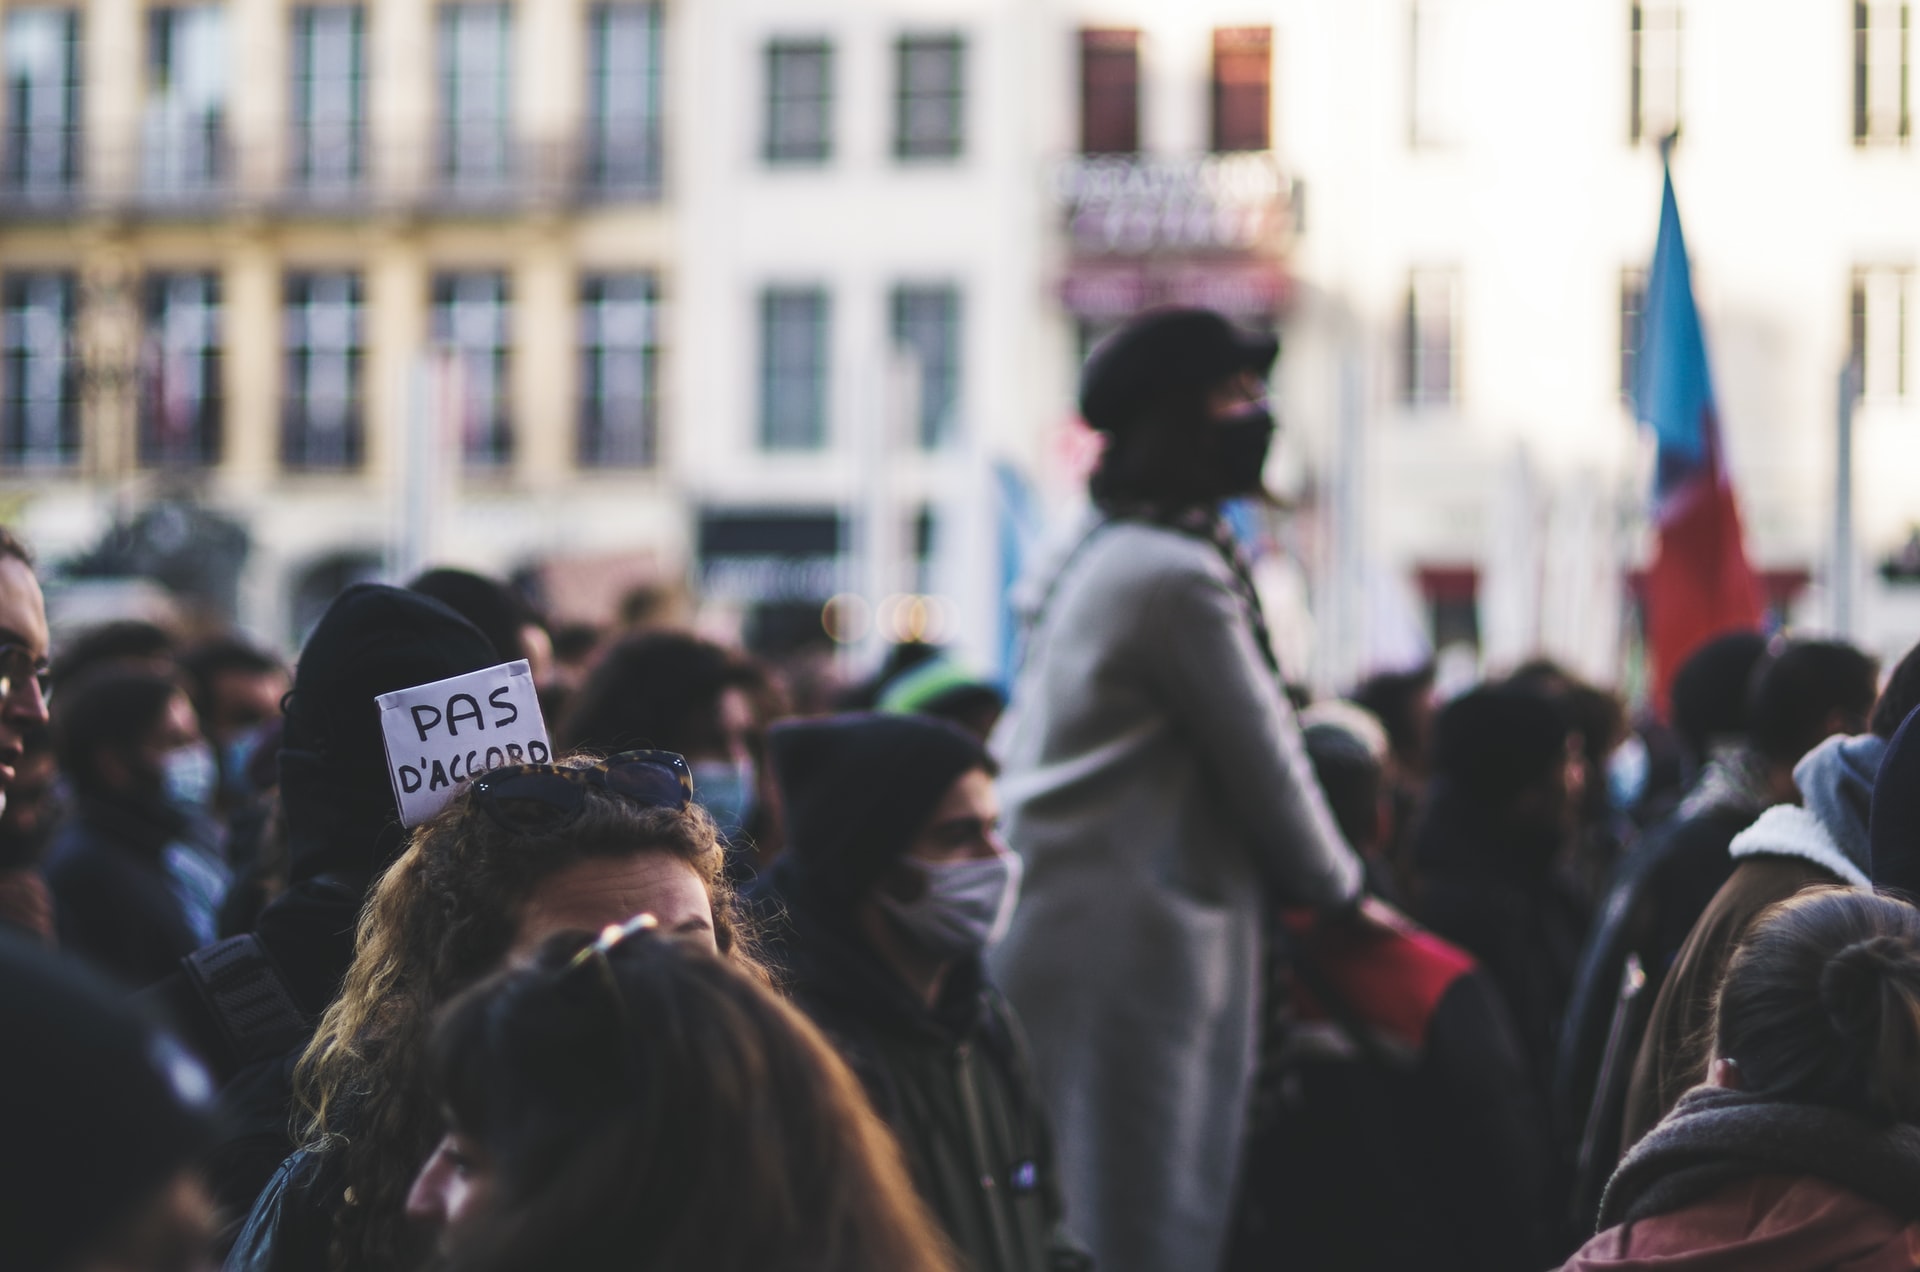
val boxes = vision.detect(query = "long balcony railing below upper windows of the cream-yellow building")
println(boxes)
[0,136,660,221]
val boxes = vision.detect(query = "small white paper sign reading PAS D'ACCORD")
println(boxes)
[374,659,553,826]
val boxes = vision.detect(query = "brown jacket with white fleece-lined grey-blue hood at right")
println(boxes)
[1620,734,1887,1145]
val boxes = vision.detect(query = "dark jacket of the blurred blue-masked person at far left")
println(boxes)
[46,795,225,990]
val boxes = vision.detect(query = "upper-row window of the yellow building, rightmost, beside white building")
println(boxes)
[588,4,660,194]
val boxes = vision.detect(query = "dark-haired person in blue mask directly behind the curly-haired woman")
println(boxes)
[557,632,768,878]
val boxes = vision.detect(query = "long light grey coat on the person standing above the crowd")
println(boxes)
[993,521,1361,1272]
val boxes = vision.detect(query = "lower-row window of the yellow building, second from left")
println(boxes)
[140,273,221,467]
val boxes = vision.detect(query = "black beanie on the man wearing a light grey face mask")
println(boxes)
[766,715,993,901]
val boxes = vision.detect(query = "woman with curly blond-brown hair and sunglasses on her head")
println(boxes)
[227,751,758,1272]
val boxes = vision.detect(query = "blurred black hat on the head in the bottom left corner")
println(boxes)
[0,934,213,1272]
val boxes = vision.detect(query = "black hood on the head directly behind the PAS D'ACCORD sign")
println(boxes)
[280,582,499,878]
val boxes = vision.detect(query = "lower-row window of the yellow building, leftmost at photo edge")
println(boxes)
[0,273,81,469]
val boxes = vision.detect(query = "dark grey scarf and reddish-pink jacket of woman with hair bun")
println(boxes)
[1567,1088,1920,1272]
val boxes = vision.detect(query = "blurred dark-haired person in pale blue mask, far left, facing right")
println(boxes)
[46,665,232,990]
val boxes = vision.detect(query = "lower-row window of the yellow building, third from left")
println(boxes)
[280,273,367,469]
